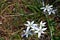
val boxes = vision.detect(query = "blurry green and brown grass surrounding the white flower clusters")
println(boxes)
[0,0,60,40]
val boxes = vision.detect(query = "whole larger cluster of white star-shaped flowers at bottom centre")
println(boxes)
[22,21,47,38]
